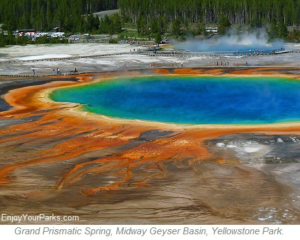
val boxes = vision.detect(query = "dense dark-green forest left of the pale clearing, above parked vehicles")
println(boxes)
[0,0,118,32]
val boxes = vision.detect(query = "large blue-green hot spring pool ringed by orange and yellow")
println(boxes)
[50,77,300,124]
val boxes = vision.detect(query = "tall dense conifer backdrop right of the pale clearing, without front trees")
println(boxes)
[118,0,300,25]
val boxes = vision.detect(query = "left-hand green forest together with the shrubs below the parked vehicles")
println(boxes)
[0,0,122,47]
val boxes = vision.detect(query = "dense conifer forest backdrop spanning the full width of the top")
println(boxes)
[0,0,300,33]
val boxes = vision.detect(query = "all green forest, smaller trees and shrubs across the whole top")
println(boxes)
[0,0,300,46]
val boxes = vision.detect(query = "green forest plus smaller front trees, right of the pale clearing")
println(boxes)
[118,0,300,40]
